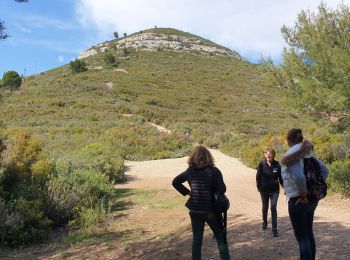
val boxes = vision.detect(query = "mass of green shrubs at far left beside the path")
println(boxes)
[0,131,117,247]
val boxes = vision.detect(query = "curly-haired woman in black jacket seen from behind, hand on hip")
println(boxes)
[172,146,230,260]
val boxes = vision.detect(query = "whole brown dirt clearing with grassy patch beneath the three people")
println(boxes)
[5,150,350,260]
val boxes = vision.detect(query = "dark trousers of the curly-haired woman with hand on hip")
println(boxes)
[190,211,230,260]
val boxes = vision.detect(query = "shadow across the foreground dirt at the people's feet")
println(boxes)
[118,216,350,260]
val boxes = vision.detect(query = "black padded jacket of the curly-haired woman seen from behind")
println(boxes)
[173,166,226,213]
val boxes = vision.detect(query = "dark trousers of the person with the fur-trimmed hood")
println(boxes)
[288,198,318,260]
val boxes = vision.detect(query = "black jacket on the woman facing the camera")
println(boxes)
[256,160,283,192]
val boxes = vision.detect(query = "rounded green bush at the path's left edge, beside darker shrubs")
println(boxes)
[46,170,114,228]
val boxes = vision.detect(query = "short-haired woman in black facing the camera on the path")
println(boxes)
[256,148,283,237]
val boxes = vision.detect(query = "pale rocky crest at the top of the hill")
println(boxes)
[78,29,245,60]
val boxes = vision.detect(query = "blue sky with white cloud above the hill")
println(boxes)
[0,0,349,75]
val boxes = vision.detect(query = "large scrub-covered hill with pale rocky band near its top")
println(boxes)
[1,28,322,167]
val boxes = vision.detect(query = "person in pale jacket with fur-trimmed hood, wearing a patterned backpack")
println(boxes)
[280,128,329,260]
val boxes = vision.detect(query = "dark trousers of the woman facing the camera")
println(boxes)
[260,191,279,231]
